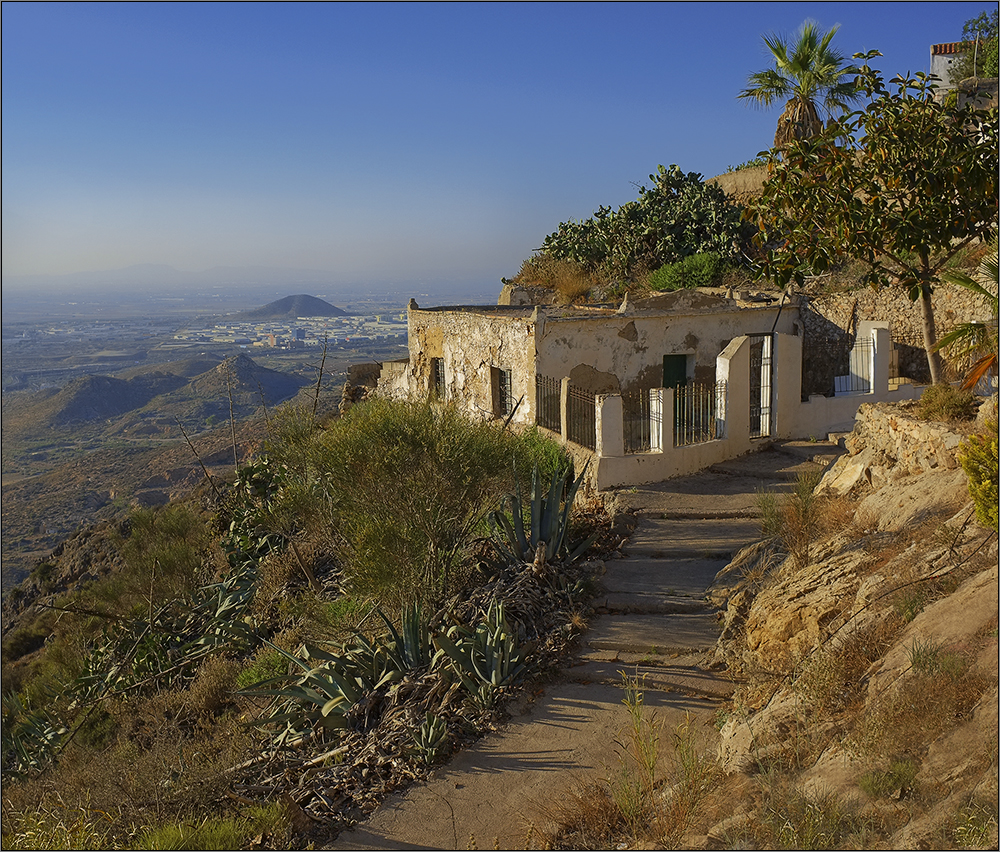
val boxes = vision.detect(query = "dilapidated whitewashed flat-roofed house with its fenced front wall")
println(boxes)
[378,290,919,488]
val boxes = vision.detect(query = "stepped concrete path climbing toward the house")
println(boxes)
[328,442,842,849]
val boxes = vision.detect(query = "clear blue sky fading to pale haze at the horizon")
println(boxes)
[2,2,996,288]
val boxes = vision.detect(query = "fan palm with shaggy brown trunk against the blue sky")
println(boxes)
[736,21,861,148]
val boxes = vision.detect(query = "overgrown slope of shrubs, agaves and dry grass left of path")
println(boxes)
[3,400,612,848]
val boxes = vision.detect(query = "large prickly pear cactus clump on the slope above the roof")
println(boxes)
[542,165,744,278]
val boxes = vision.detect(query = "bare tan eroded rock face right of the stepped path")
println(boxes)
[710,406,998,848]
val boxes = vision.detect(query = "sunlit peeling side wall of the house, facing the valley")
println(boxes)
[407,308,535,422]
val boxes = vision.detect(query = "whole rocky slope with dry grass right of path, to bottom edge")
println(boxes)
[704,397,998,849]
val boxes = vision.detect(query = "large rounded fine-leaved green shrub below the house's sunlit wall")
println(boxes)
[266,399,561,608]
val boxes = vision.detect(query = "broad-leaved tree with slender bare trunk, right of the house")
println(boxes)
[746,51,998,383]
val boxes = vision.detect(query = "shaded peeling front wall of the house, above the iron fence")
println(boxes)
[536,300,801,393]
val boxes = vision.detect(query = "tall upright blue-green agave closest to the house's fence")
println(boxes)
[491,465,596,565]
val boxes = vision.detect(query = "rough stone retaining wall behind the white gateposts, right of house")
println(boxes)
[799,284,992,399]
